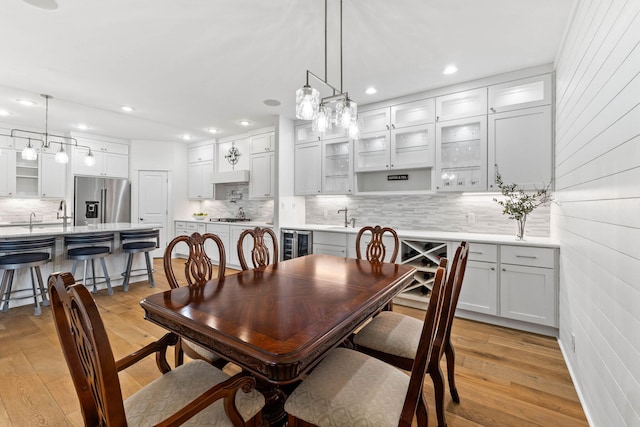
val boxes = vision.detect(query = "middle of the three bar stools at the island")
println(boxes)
[64,233,115,295]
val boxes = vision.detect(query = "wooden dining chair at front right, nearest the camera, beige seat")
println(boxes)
[284,267,451,427]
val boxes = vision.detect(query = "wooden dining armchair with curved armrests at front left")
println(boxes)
[48,273,264,426]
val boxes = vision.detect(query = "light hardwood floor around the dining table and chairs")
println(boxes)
[0,259,587,427]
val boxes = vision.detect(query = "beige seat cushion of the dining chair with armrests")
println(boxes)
[124,360,264,427]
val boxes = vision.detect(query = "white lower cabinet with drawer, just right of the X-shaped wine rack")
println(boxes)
[458,243,498,316]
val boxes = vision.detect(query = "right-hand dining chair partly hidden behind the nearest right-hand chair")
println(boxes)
[353,242,469,427]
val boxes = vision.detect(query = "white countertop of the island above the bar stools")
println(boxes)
[0,222,162,239]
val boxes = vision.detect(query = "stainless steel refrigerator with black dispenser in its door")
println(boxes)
[73,176,131,225]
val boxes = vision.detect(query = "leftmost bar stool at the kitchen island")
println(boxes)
[0,237,56,316]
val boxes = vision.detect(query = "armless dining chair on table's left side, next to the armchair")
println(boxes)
[163,232,227,368]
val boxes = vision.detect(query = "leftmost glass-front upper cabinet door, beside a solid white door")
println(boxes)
[322,139,353,194]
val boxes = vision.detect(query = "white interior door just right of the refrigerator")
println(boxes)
[138,171,169,258]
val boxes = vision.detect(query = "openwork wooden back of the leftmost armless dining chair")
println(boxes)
[164,232,227,289]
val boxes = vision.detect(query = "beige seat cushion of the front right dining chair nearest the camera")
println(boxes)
[284,348,409,427]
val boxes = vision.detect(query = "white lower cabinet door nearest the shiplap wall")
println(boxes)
[500,264,558,327]
